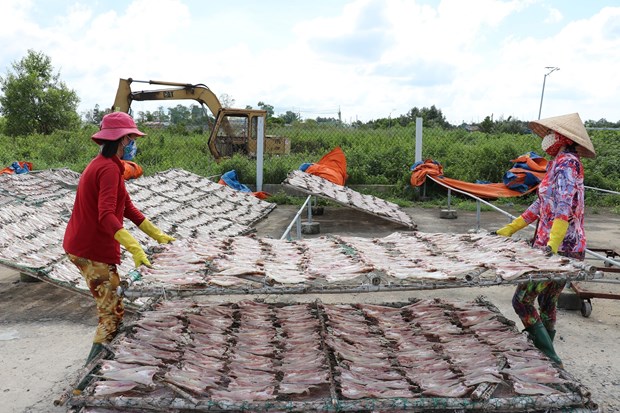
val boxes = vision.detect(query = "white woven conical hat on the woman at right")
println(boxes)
[530,113,596,158]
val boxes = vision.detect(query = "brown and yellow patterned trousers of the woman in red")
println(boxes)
[67,254,125,343]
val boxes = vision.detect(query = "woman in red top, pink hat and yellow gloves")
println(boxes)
[63,112,174,364]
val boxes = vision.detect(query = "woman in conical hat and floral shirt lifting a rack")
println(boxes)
[497,113,596,365]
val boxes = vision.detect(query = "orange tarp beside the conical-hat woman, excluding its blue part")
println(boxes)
[410,155,547,198]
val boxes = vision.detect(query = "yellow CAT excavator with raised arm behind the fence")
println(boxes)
[112,78,291,161]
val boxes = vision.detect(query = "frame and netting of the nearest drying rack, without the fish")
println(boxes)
[60,297,598,412]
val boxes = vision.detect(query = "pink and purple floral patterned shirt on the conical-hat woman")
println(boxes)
[521,150,586,256]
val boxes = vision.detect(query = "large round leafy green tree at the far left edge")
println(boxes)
[0,50,80,136]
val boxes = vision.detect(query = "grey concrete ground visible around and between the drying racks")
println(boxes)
[0,206,620,412]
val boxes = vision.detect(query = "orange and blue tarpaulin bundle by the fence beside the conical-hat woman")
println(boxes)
[410,152,547,198]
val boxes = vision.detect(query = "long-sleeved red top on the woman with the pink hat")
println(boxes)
[62,154,144,264]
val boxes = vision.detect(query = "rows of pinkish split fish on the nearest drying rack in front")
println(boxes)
[66,299,584,410]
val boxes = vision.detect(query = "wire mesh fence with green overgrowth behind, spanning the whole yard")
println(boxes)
[0,117,620,196]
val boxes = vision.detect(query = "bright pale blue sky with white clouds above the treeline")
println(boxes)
[0,0,620,124]
